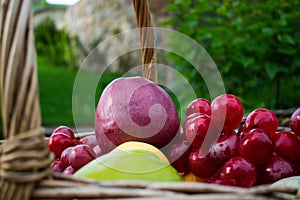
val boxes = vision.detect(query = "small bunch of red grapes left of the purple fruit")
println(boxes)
[48,126,103,174]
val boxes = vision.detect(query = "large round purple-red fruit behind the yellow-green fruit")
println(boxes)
[95,77,180,153]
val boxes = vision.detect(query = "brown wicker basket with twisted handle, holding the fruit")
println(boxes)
[0,0,300,200]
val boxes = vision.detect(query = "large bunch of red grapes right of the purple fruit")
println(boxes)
[167,94,300,187]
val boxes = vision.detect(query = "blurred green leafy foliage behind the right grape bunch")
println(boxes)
[166,0,300,109]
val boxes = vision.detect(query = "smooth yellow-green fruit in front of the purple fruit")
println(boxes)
[74,145,182,182]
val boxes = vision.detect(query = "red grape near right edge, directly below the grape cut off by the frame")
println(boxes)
[275,131,300,161]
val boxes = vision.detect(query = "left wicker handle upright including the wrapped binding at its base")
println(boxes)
[0,0,53,200]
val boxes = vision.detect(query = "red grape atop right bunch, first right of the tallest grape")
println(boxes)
[244,108,278,139]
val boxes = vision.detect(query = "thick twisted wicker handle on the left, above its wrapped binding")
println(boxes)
[0,0,41,138]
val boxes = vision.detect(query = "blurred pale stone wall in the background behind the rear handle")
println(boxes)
[65,0,168,71]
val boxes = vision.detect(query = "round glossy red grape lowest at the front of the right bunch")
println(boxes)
[220,157,257,188]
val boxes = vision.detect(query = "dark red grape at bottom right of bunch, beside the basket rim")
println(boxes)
[257,155,297,184]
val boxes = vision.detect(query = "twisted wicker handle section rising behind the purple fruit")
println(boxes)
[133,0,157,82]
